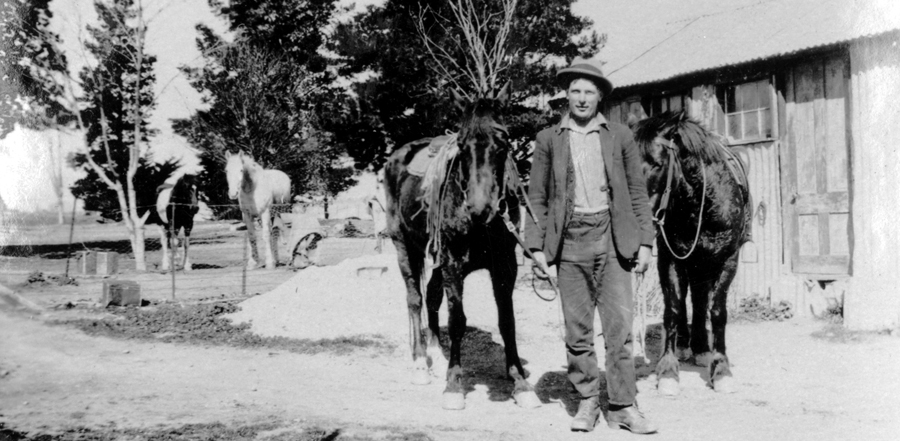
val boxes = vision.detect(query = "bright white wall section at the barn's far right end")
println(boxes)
[844,35,900,330]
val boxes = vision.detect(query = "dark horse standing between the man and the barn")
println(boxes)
[635,112,752,395]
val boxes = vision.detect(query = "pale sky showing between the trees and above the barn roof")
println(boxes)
[0,0,900,211]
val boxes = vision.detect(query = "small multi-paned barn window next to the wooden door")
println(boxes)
[716,80,772,142]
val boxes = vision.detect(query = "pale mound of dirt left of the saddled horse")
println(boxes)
[225,254,408,344]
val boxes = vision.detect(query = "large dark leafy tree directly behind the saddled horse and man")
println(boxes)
[329,0,606,171]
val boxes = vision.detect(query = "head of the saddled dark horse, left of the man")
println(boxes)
[451,83,510,222]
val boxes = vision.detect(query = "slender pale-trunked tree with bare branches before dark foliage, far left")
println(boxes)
[73,0,163,271]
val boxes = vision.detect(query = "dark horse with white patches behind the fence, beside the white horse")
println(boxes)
[145,175,200,271]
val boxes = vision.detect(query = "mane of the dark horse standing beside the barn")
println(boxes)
[635,110,726,163]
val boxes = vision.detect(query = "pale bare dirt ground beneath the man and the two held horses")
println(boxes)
[0,223,900,440]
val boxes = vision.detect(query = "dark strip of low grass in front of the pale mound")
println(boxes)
[51,301,394,355]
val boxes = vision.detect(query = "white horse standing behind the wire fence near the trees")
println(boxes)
[225,152,291,269]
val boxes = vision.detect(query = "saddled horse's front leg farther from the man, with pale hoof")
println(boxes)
[442,261,466,410]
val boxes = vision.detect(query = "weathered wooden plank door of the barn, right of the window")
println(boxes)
[781,56,850,278]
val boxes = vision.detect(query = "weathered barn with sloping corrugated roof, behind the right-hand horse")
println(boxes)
[604,0,900,330]
